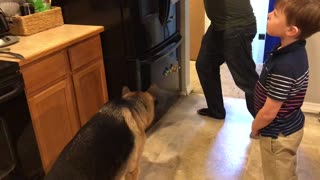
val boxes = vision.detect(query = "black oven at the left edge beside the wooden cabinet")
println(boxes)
[0,61,44,180]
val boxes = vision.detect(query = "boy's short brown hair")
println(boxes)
[274,0,320,39]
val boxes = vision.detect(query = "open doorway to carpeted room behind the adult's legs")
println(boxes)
[190,0,269,98]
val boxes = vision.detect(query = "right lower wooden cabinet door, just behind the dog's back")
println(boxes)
[73,59,108,126]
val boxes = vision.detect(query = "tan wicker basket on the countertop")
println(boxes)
[9,7,63,36]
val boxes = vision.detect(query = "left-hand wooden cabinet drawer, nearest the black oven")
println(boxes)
[21,51,69,95]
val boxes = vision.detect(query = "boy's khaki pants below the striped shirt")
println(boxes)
[260,128,303,180]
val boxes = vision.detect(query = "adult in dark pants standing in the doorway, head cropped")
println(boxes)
[196,0,258,119]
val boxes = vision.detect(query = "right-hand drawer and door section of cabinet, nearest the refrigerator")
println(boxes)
[68,36,108,126]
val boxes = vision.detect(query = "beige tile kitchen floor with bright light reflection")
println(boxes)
[140,94,320,180]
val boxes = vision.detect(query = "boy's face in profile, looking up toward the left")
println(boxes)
[267,8,290,38]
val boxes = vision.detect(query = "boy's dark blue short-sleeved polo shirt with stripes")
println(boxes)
[254,40,309,138]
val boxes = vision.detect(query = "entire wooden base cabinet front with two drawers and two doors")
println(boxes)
[21,34,108,173]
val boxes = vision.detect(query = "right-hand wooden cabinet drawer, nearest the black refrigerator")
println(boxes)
[68,36,102,70]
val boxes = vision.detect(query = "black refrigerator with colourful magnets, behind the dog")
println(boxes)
[52,0,182,121]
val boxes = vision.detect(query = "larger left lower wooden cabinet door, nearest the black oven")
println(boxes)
[28,79,80,172]
